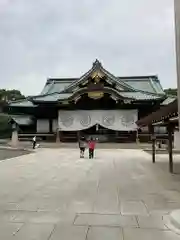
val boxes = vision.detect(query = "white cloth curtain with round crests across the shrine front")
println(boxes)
[58,109,138,131]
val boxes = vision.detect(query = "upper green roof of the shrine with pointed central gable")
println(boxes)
[41,60,165,95]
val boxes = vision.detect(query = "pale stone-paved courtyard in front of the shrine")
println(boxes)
[0,149,180,240]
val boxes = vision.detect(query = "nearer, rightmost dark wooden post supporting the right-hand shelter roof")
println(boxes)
[167,123,174,173]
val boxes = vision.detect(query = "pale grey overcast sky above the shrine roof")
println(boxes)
[0,0,176,95]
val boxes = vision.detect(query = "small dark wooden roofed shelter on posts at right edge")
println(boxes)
[136,99,178,173]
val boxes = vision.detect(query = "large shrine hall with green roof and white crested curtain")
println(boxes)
[5,60,174,142]
